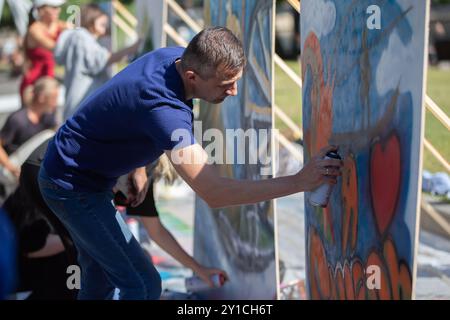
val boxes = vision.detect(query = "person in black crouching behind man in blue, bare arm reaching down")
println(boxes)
[3,139,223,300]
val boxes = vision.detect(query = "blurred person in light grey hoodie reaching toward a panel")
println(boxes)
[54,4,140,120]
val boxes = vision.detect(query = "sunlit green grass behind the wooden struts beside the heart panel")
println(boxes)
[275,61,450,172]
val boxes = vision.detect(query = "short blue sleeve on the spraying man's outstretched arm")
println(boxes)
[142,106,195,150]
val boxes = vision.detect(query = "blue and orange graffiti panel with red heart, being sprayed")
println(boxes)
[301,0,429,299]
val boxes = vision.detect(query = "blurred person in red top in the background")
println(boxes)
[20,0,68,100]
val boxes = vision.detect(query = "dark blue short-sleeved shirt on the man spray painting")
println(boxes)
[43,47,194,192]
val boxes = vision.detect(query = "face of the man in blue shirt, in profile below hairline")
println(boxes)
[194,70,242,104]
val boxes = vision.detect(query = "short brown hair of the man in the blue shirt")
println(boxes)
[181,27,246,79]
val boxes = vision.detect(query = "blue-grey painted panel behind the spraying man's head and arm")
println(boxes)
[194,0,277,299]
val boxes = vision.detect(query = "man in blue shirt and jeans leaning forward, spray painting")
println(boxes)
[39,27,341,299]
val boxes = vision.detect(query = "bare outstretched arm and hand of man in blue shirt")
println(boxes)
[166,144,342,208]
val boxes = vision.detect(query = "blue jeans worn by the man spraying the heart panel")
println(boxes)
[39,166,161,300]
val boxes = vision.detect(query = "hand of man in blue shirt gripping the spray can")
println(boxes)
[296,146,342,191]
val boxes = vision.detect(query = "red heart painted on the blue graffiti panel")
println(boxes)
[370,133,401,234]
